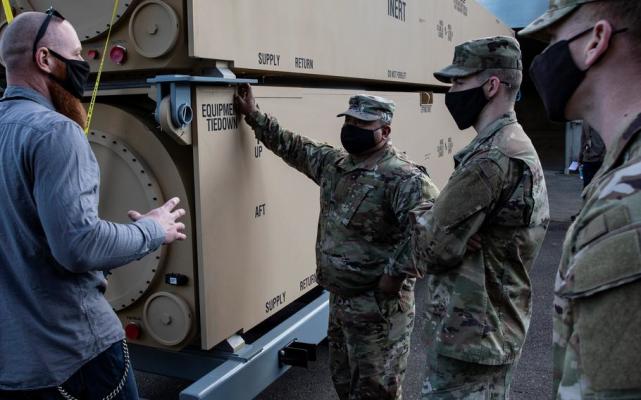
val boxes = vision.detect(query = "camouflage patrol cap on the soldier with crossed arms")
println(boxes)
[434,36,523,83]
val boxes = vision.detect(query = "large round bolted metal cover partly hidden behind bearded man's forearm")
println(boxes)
[88,130,164,311]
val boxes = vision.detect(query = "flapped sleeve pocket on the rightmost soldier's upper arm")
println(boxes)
[557,225,641,391]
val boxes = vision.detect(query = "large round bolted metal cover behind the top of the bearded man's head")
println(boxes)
[15,0,135,41]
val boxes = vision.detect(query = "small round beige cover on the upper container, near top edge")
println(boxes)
[129,0,180,58]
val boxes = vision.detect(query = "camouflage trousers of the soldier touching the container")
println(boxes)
[327,285,414,400]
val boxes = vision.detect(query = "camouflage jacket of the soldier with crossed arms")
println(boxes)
[410,113,549,365]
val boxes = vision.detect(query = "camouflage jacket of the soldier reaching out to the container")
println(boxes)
[246,112,438,296]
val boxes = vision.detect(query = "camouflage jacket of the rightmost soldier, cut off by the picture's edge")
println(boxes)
[554,114,641,400]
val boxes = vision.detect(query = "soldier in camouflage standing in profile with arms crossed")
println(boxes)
[410,36,549,400]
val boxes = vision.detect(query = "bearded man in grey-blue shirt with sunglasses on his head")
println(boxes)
[0,10,186,400]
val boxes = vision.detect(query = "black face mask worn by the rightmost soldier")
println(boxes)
[530,28,627,122]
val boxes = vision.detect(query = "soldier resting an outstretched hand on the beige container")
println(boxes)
[235,86,438,400]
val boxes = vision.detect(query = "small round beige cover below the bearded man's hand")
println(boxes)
[142,292,192,346]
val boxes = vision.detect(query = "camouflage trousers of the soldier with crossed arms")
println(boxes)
[421,354,516,400]
